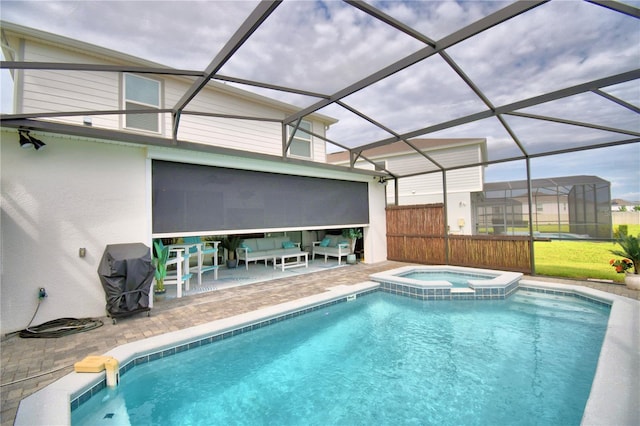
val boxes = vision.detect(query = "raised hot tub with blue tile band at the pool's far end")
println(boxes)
[369,265,522,300]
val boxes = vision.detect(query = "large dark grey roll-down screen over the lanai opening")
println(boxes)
[152,160,369,234]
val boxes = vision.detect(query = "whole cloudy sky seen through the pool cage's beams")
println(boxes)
[0,0,640,201]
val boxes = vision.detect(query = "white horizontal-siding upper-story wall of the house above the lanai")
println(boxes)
[9,36,330,163]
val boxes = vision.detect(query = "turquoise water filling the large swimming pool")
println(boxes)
[72,291,609,425]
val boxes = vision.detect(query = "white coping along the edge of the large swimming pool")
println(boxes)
[15,280,640,426]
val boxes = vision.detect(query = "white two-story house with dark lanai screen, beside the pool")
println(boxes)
[0,23,386,333]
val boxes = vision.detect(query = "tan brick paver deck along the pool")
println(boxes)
[0,261,640,426]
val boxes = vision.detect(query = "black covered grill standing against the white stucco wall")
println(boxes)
[98,243,155,316]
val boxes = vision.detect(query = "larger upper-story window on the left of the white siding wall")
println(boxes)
[123,74,160,132]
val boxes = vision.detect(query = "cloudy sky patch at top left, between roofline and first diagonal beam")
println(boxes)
[0,0,257,69]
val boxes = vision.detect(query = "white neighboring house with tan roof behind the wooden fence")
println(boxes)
[327,138,487,235]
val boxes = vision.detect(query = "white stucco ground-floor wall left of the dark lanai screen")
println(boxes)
[0,131,150,334]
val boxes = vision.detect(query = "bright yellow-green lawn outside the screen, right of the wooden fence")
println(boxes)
[534,225,640,282]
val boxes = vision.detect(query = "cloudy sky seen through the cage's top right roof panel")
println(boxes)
[450,1,640,106]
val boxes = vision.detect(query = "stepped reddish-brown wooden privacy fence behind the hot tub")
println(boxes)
[387,204,531,274]
